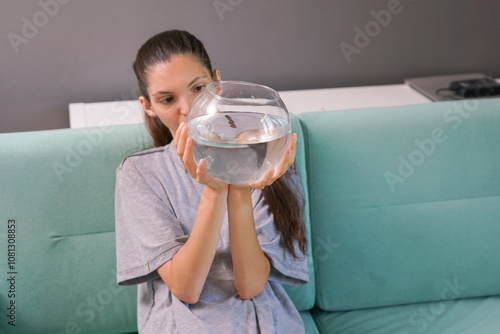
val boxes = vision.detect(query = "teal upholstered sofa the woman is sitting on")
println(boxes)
[0,99,500,334]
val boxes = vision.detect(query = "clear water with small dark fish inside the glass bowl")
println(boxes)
[187,112,290,184]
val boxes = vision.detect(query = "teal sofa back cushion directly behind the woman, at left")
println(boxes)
[0,115,315,334]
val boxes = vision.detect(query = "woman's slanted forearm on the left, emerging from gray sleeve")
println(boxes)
[158,186,228,304]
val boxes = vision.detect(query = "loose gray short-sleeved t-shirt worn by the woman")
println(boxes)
[115,144,309,334]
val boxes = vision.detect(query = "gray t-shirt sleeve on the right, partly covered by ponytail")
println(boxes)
[254,165,309,285]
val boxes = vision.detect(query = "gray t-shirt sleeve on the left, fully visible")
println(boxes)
[115,159,187,285]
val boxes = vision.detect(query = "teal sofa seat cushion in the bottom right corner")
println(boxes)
[311,296,500,334]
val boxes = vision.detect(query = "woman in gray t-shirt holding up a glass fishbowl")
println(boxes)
[115,30,308,334]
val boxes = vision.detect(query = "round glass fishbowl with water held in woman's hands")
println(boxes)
[186,81,291,184]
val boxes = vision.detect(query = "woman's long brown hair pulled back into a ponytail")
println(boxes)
[133,30,307,258]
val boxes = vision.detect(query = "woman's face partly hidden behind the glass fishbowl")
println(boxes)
[139,55,220,136]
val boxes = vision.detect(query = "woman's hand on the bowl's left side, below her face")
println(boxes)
[174,122,228,190]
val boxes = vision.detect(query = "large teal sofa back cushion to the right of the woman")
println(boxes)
[299,99,500,311]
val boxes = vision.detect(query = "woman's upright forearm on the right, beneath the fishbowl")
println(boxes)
[227,186,271,299]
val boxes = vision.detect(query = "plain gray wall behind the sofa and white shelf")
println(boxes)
[0,0,500,132]
